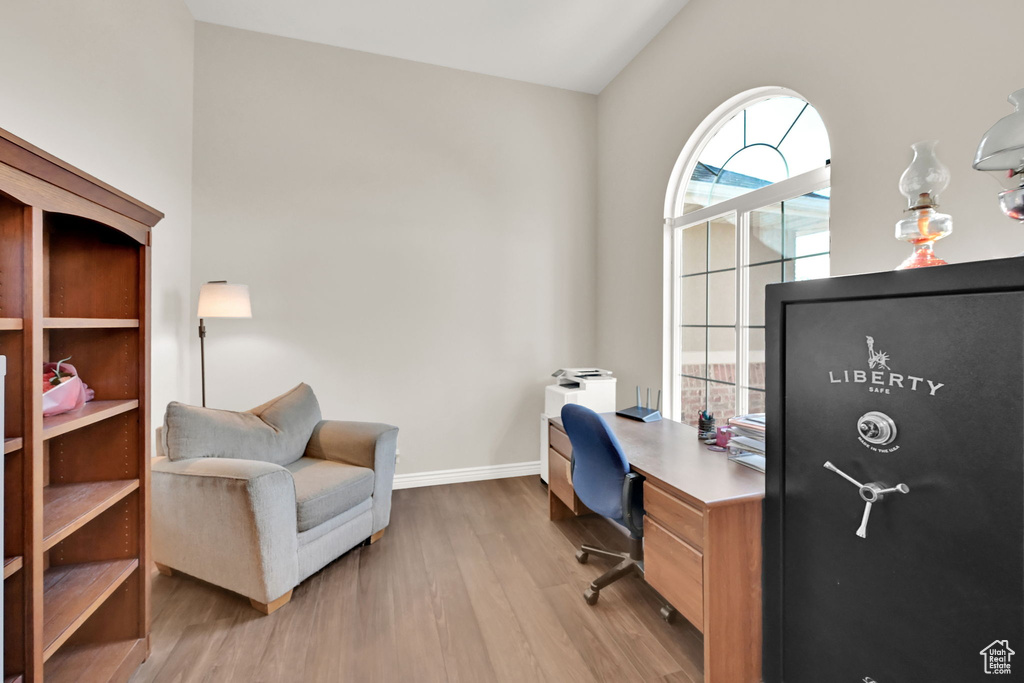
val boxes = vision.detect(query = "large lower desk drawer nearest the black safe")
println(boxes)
[643,517,703,633]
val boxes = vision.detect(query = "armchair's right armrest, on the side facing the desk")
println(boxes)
[305,420,398,533]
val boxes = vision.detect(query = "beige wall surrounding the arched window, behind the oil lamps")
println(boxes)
[597,0,1024,400]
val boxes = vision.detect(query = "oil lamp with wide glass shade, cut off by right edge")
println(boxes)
[974,89,1024,222]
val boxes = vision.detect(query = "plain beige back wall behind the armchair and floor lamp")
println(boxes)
[193,23,596,473]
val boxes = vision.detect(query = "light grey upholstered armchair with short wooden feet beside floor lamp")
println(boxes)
[153,384,398,614]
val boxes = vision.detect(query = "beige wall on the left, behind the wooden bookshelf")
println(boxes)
[0,0,195,424]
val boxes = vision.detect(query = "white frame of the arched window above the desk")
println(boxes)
[662,87,831,420]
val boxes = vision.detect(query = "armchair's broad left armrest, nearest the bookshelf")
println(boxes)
[152,458,298,603]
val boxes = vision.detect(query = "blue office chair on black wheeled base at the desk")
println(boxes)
[562,403,647,606]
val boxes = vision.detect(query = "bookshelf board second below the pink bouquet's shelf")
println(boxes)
[43,558,138,661]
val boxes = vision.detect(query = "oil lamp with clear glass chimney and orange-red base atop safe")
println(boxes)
[896,140,953,270]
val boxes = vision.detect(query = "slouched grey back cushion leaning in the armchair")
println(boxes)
[162,384,321,465]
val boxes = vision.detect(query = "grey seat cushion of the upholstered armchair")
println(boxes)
[285,458,374,531]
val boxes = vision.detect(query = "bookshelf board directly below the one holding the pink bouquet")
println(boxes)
[43,479,138,551]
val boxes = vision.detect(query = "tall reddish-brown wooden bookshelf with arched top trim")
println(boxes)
[0,125,163,683]
